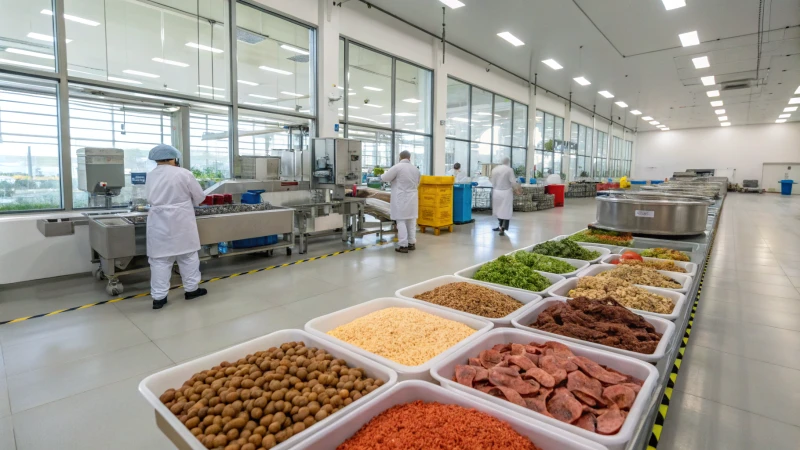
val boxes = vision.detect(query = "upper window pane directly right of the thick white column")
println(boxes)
[347,43,392,127]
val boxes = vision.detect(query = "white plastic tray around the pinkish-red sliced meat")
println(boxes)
[431,328,658,450]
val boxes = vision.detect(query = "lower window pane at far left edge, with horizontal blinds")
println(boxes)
[0,75,61,211]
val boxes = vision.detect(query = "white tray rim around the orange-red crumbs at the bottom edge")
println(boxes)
[295,381,605,450]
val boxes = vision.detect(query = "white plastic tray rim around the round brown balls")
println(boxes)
[139,330,397,450]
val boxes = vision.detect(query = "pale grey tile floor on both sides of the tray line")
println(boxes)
[0,195,800,450]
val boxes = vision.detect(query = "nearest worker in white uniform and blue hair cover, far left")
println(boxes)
[145,144,208,309]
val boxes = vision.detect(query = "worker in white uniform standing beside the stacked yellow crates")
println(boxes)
[381,150,420,253]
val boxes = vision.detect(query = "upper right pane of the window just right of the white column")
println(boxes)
[395,61,432,134]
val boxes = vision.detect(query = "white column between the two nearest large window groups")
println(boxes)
[317,0,344,137]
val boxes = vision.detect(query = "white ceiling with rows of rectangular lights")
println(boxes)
[371,0,800,131]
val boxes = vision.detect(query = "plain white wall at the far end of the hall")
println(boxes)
[633,123,800,184]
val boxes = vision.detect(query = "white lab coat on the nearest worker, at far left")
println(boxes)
[145,165,206,258]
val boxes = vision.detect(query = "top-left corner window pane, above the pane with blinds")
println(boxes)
[0,0,55,72]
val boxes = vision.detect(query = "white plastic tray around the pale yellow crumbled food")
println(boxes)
[305,297,493,381]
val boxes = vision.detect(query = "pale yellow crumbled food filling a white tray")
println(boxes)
[328,308,475,366]
